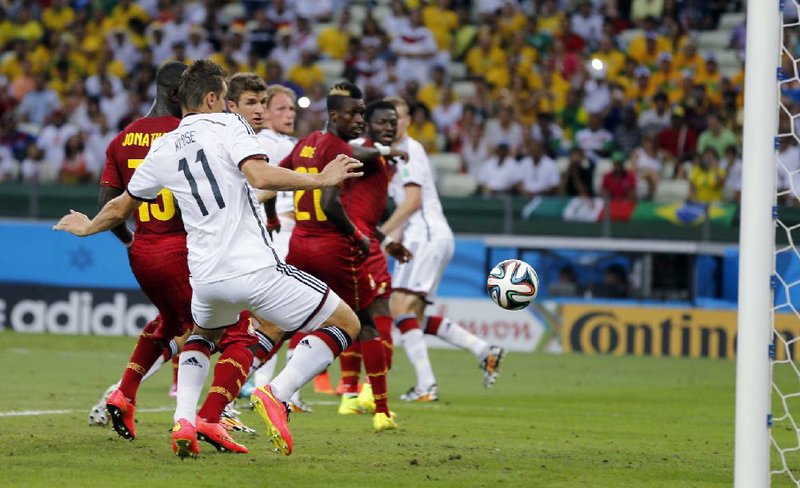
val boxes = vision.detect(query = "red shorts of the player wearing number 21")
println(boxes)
[286,231,376,310]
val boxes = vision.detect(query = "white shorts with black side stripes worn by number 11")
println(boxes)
[192,264,339,332]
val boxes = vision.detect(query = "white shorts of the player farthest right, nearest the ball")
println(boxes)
[392,239,454,303]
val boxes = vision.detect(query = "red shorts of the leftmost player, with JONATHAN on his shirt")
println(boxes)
[128,234,194,341]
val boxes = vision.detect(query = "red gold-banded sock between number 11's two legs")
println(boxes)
[197,344,253,424]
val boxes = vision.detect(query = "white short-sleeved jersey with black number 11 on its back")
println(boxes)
[128,113,278,283]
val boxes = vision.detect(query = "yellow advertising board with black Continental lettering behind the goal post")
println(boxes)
[557,304,800,359]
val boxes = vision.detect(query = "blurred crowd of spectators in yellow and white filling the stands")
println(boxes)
[0,0,800,206]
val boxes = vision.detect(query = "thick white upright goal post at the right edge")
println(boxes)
[734,0,780,488]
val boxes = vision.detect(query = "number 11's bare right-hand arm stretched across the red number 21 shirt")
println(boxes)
[241,154,364,191]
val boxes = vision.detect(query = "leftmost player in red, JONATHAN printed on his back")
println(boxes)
[94,62,258,452]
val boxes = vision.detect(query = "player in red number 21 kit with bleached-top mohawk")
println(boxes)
[281,82,409,431]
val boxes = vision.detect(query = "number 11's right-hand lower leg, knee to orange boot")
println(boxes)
[251,301,361,456]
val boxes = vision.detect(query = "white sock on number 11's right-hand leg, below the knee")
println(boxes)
[269,335,333,402]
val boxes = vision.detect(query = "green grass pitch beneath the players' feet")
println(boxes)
[0,332,748,488]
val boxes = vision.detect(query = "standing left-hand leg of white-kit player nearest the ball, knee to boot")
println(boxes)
[389,290,439,402]
